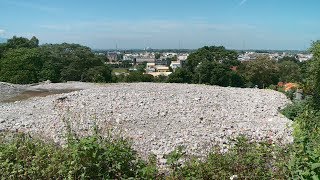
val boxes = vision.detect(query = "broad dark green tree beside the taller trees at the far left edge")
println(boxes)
[40,43,111,82]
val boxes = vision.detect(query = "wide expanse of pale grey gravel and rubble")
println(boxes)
[0,82,293,163]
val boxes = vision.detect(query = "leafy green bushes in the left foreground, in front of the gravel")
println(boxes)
[0,130,158,179]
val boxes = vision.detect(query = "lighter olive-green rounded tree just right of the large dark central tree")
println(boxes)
[238,56,279,88]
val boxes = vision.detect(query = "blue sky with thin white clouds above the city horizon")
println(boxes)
[0,0,320,50]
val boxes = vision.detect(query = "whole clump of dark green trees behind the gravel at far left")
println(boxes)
[0,37,112,84]
